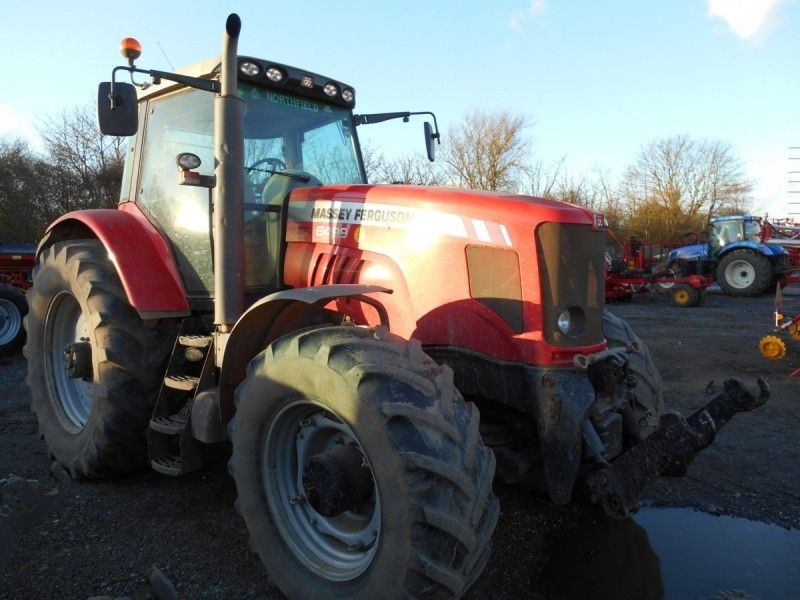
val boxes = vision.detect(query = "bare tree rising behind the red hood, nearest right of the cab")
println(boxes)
[442,110,530,192]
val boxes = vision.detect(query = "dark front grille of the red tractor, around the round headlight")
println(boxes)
[536,223,606,346]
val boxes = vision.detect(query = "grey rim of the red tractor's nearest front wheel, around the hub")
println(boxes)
[261,399,381,581]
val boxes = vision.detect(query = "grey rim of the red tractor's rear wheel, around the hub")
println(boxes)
[46,293,94,431]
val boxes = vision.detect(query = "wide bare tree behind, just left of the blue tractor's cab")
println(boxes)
[621,136,752,239]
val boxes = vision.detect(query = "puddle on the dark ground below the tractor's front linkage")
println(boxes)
[540,508,800,600]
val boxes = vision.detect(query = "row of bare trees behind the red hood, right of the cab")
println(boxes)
[365,111,753,240]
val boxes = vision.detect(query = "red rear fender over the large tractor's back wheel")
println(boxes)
[41,203,189,319]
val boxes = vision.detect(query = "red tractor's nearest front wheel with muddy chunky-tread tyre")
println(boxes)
[230,326,499,598]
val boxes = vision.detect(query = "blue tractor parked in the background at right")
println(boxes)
[667,215,791,296]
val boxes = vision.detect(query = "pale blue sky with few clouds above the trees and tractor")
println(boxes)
[0,0,800,217]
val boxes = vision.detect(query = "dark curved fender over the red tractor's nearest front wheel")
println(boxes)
[219,284,392,422]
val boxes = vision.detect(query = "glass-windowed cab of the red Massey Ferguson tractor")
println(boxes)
[116,57,365,304]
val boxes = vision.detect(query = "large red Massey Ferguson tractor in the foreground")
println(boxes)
[25,15,767,598]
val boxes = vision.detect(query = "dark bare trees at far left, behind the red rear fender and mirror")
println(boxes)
[0,107,124,244]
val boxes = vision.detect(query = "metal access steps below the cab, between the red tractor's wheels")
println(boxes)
[147,319,215,477]
